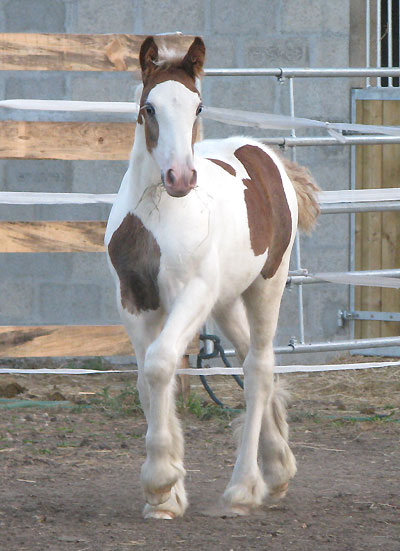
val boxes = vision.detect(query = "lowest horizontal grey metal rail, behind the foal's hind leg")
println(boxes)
[225,337,400,357]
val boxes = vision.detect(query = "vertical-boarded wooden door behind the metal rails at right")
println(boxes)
[355,99,400,338]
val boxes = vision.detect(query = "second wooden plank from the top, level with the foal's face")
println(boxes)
[0,121,135,161]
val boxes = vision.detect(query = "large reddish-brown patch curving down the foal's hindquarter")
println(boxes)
[235,145,292,279]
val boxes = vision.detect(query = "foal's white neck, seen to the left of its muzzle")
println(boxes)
[129,125,161,206]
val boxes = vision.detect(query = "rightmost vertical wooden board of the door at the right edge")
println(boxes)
[380,100,400,337]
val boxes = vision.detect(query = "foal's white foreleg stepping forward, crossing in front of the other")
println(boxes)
[141,278,214,518]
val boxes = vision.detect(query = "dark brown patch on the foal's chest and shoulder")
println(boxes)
[108,213,161,314]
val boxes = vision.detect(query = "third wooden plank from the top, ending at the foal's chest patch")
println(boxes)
[0,222,106,253]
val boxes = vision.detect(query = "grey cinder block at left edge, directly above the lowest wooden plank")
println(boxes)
[0,277,35,325]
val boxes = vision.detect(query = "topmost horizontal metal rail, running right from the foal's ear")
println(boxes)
[204,67,400,78]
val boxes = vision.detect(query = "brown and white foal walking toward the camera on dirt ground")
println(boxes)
[105,37,318,519]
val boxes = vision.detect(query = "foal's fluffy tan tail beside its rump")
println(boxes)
[281,157,320,233]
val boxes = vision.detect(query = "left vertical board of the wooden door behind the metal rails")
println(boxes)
[360,100,383,338]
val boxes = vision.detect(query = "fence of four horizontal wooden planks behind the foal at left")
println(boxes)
[0,33,198,358]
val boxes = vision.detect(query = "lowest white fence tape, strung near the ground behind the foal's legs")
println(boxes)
[0,361,400,375]
